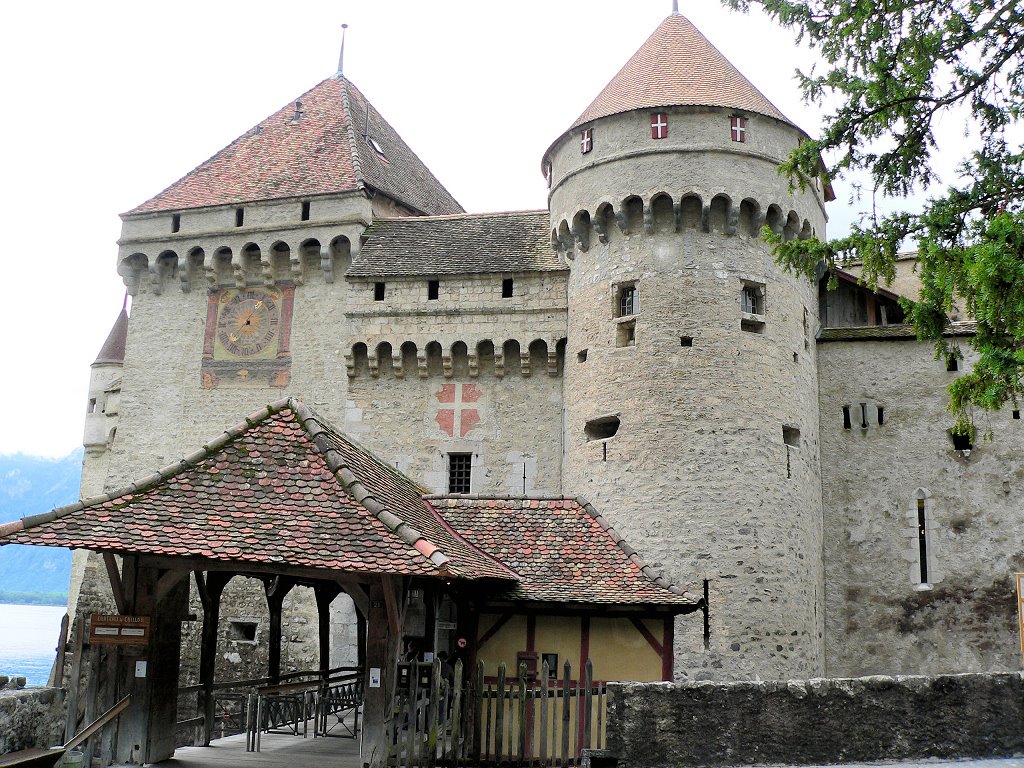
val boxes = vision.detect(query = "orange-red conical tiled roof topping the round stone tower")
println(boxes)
[572,14,793,128]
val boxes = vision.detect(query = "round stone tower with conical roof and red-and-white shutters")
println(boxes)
[544,14,830,679]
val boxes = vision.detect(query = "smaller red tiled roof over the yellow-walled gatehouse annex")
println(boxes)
[428,497,697,608]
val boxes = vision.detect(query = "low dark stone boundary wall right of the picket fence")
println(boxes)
[606,673,1024,768]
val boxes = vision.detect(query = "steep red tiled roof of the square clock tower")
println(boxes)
[129,76,462,214]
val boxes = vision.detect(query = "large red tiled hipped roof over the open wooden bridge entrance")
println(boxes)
[0,400,516,580]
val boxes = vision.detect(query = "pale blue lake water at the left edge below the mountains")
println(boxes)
[0,603,68,685]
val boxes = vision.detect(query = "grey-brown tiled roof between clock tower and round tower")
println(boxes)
[346,211,565,278]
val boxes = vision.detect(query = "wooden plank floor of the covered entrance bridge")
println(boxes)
[148,723,362,768]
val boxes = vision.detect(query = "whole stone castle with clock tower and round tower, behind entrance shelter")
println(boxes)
[37,3,1024,696]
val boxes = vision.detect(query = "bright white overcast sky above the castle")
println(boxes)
[0,0,872,456]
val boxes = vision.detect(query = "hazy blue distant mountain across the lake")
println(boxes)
[0,449,82,604]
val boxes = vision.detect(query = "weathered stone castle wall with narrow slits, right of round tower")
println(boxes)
[818,340,1024,675]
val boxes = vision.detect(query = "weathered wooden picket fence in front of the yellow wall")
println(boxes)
[387,660,607,768]
